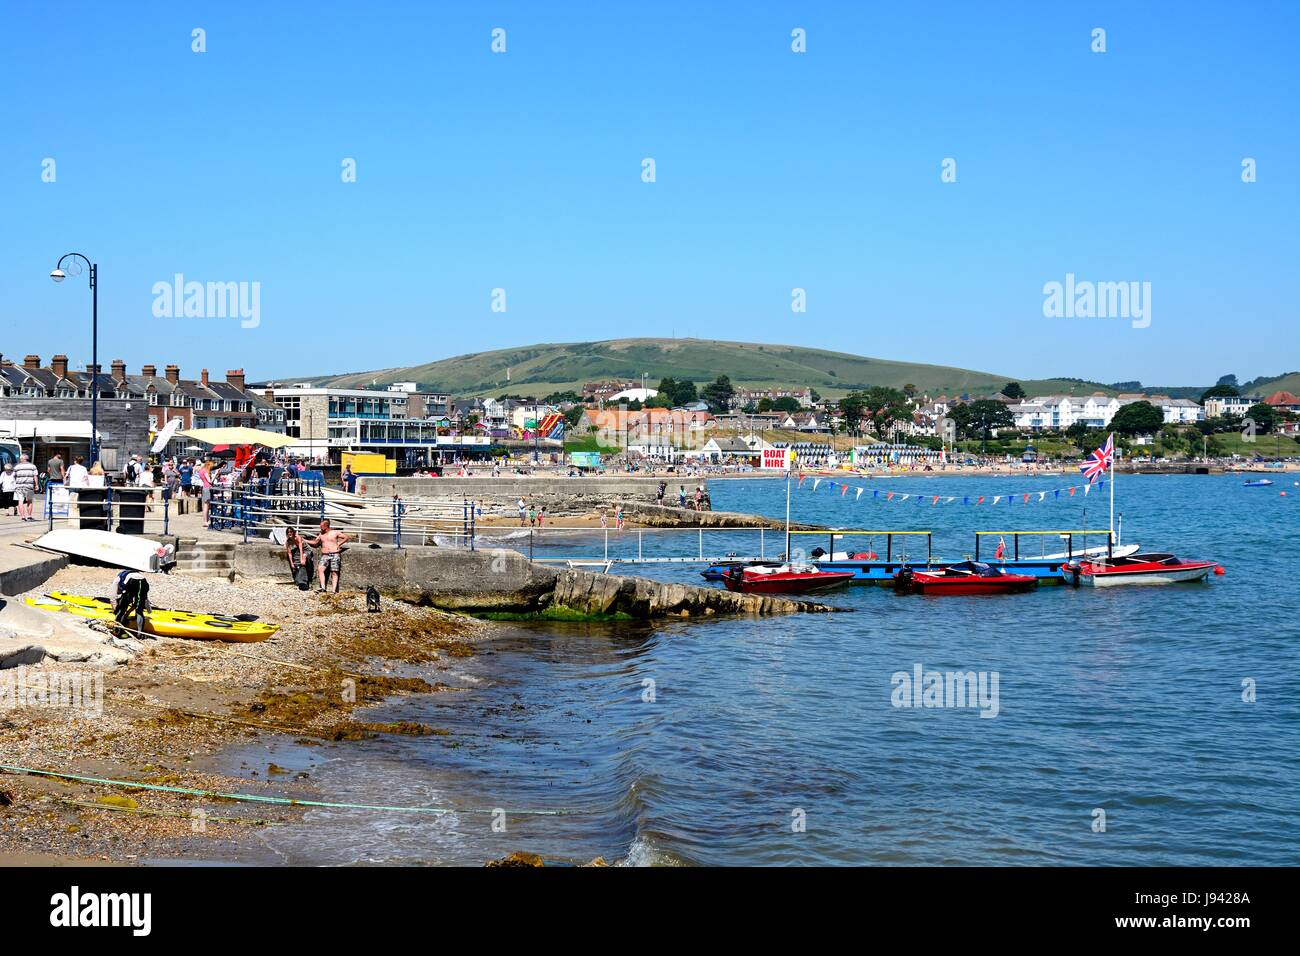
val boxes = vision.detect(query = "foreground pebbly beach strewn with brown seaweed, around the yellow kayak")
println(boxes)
[0,566,488,866]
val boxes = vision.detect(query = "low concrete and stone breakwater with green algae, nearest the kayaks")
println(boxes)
[234,544,833,618]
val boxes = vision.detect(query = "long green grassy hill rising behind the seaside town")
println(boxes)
[293,338,1108,397]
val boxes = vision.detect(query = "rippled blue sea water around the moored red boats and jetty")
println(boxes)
[220,475,1300,865]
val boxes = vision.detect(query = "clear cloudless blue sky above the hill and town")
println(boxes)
[0,0,1300,385]
